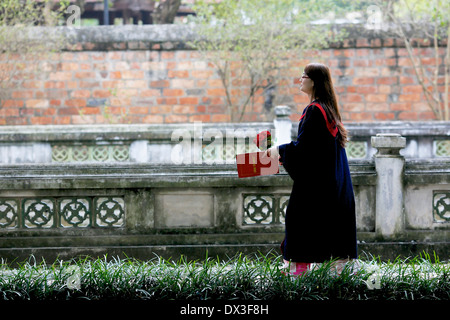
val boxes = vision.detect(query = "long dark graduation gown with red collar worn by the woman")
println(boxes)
[279,102,357,262]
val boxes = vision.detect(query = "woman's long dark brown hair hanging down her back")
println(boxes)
[304,63,347,147]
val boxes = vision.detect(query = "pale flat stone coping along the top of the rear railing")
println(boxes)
[0,121,450,142]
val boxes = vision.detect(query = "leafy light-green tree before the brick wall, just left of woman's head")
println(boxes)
[193,0,345,121]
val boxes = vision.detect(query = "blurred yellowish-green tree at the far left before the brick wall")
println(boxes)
[0,0,68,102]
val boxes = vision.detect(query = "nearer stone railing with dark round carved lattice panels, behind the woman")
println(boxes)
[0,154,450,260]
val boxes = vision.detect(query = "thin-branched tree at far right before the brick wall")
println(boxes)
[375,0,450,121]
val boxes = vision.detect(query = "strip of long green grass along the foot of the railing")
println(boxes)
[0,254,450,301]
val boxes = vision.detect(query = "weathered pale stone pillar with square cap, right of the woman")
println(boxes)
[371,133,406,239]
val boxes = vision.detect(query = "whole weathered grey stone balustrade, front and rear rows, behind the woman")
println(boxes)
[0,118,450,261]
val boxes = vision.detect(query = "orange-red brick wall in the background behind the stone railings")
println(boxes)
[0,26,444,125]
